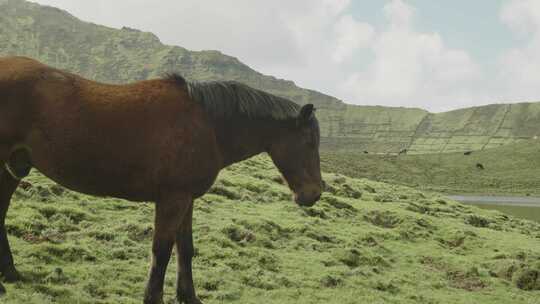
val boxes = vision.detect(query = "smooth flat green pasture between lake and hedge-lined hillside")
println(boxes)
[321,140,540,195]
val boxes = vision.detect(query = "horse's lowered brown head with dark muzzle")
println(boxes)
[268,104,322,206]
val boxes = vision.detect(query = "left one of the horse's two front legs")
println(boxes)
[144,194,192,304]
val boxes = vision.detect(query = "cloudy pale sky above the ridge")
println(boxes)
[29,0,540,112]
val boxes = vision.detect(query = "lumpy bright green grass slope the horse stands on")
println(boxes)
[0,157,540,304]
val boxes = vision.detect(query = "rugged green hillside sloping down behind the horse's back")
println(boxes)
[0,0,341,107]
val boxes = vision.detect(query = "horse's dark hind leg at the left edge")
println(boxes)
[0,168,21,282]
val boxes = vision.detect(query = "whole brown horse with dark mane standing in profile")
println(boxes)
[0,57,322,303]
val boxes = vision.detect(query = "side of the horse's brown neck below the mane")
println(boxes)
[216,119,283,167]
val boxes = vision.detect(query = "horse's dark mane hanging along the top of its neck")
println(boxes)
[167,74,300,120]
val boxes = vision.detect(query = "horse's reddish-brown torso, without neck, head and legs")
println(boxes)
[0,58,222,201]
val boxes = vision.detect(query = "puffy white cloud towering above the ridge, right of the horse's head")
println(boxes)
[341,0,480,110]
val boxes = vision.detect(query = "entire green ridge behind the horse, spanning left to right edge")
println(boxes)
[0,0,540,153]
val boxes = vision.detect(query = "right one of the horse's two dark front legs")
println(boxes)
[176,202,202,304]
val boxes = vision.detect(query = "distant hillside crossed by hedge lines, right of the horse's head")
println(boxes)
[322,103,540,154]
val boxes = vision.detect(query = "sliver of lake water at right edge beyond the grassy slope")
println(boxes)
[449,195,540,222]
